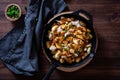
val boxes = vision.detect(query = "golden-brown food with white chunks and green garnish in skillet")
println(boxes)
[46,17,93,64]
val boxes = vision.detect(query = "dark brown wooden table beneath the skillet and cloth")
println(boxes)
[0,0,120,80]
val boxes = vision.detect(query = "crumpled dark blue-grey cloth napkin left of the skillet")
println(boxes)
[0,0,67,76]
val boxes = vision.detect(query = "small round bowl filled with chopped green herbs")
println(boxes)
[5,4,21,21]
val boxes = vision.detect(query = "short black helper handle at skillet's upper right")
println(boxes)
[73,9,93,25]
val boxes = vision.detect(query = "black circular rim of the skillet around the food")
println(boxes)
[41,11,97,68]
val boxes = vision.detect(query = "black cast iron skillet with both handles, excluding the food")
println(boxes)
[42,10,96,80]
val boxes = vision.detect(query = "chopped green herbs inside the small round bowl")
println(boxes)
[6,5,20,18]
